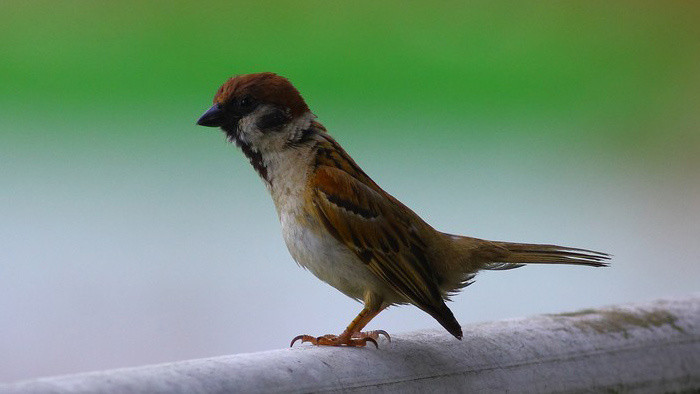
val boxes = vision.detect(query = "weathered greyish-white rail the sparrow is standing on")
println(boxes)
[0,294,700,393]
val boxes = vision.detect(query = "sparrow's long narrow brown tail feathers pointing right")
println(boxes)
[483,242,611,270]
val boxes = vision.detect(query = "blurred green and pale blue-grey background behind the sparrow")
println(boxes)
[0,1,700,381]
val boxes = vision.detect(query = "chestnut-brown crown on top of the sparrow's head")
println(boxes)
[214,72,309,116]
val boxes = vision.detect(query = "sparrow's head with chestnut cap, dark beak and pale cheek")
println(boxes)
[197,72,314,151]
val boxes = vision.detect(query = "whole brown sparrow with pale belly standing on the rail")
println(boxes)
[197,72,610,347]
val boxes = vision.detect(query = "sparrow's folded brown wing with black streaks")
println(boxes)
[311,163,444,314]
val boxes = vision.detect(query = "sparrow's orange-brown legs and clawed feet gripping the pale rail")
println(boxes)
[289,306,391,348]
